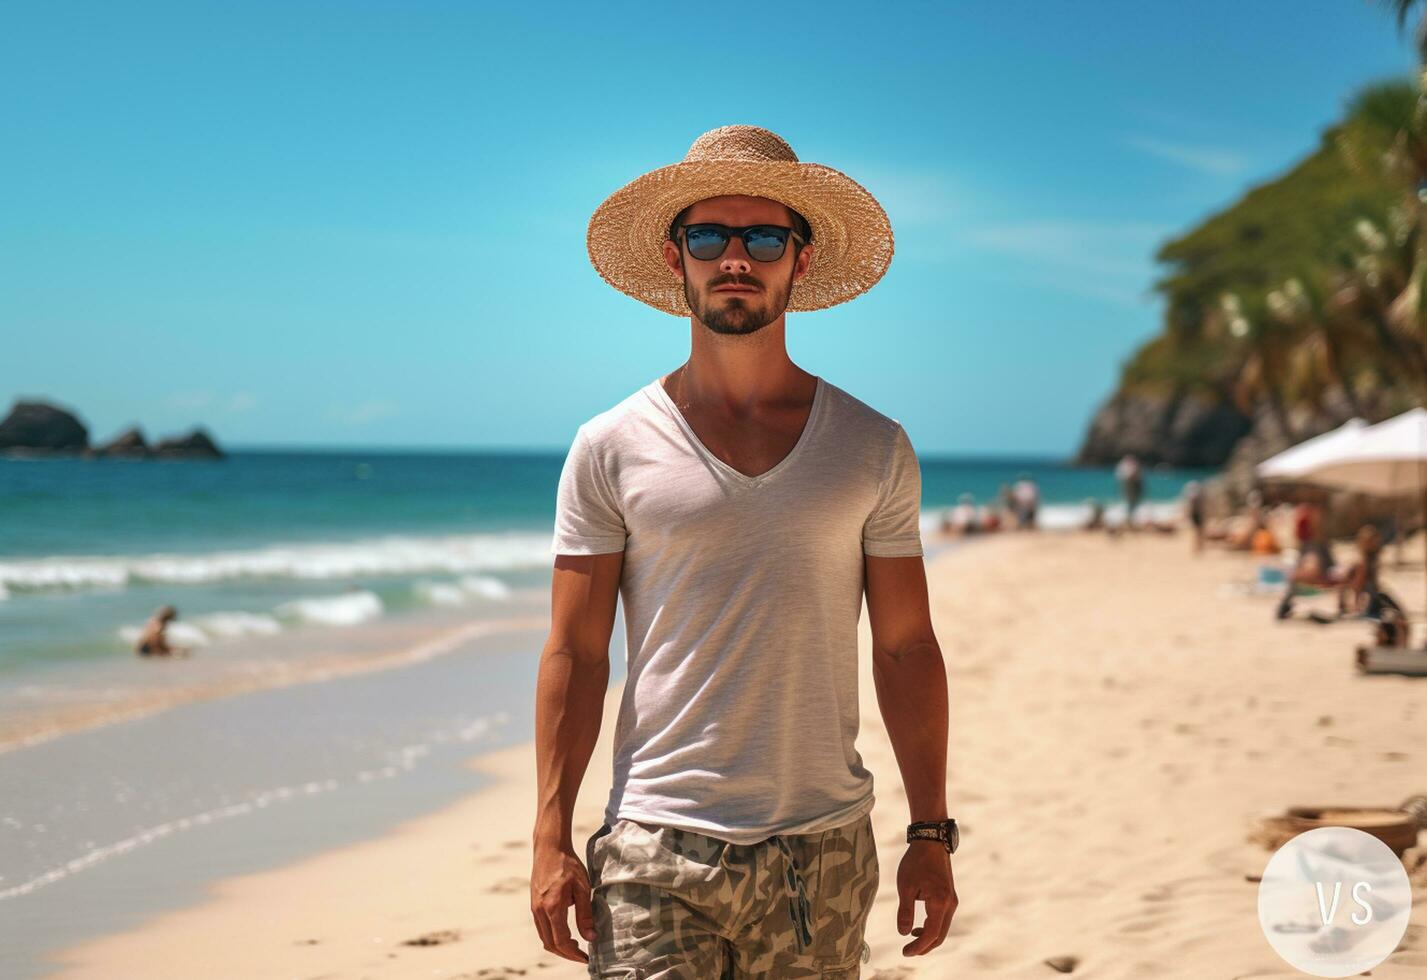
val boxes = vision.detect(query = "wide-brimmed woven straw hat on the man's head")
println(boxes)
[585,126,892,317]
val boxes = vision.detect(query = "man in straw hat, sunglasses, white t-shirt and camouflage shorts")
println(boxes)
[531,126,956,980]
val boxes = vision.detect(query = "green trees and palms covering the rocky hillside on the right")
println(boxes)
[1120,81,1427,414]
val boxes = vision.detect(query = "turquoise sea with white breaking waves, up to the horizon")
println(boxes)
[0,451,1204,682]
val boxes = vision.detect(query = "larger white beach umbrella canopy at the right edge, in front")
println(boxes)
[1290,408,1427,621]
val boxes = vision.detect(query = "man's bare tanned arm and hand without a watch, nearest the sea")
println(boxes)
[531,552,624,963]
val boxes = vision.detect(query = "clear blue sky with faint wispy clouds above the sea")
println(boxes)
[0,0,1413,455]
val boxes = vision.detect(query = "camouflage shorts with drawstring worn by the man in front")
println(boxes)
[585,816,878,980]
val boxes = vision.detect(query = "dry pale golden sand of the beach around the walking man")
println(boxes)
[44,534,1427,980]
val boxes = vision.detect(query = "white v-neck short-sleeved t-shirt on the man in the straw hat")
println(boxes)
[551,378,922,843]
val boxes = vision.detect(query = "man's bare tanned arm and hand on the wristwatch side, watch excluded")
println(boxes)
[863,555,956,956]
